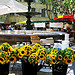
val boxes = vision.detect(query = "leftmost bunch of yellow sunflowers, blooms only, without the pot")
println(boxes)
[0,42,16,64]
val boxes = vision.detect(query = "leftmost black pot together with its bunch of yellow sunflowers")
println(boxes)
[0,42,16,75]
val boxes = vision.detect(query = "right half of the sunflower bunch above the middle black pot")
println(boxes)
[28,43,46,65]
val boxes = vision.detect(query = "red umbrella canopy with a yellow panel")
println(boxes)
[53,14,75,22]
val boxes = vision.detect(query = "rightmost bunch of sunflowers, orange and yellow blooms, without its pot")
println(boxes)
[46,48,74,64]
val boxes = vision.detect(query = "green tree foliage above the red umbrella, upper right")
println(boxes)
[39,0,75,14]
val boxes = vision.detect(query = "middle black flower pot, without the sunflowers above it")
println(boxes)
[22,62,38,75]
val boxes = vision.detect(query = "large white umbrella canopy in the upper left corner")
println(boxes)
[0,0,28,15]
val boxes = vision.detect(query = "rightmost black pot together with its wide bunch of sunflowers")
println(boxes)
[46,48,75,75]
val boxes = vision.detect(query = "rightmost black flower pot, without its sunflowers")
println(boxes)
[52,64,68,75]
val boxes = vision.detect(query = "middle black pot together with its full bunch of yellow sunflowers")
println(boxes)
[15,43,45,75]
